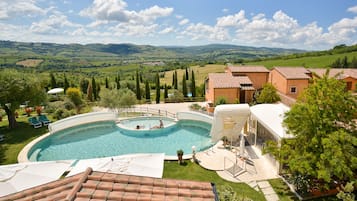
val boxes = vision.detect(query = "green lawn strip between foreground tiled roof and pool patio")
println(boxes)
[163,160,265,201]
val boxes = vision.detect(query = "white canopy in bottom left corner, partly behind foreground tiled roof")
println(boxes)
[0,161,72,196]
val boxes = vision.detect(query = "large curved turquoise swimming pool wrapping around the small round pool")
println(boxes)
[28,119,212,161]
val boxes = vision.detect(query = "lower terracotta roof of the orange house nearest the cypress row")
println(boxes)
[208,73,252,88]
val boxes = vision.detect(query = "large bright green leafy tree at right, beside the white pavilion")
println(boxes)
[273,70,357,185]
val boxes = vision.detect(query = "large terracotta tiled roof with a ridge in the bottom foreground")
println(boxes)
[0,168,217,201]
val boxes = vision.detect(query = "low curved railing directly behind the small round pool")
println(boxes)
[119,107,177,119]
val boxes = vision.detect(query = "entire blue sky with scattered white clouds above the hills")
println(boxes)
[0,0,357,50]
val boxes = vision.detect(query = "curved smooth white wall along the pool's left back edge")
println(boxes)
[48,112,118,133]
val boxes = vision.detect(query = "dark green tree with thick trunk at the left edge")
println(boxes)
[0,70,47,128]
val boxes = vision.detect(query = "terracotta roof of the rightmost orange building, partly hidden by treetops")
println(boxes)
[309,68,357,79]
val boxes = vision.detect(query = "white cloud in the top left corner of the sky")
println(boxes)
[0,0,47,20]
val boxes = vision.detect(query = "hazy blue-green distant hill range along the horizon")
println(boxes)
[0,41,304,61]
